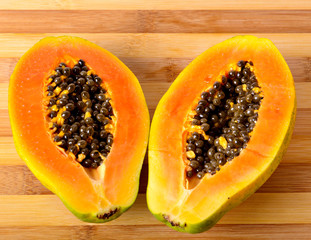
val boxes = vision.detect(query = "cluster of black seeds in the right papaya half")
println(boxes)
[186,60,262,178]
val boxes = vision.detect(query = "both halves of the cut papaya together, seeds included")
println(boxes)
[9,36,296,232]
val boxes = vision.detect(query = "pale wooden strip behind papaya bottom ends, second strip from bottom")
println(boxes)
[0,193,311,227]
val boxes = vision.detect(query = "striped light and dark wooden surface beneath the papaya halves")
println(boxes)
[0,0,311,239]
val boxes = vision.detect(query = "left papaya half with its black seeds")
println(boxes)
[9,36,149,222]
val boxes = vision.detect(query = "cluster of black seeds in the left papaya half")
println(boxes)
[47,59,113,168]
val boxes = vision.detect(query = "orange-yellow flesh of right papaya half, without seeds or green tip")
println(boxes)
[147,36,295,224]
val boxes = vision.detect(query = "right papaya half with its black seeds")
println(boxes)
[147,36,296,233]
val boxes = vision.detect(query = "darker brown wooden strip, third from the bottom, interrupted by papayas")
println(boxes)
[0,159,311,195]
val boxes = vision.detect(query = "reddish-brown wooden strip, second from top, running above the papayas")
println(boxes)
[0,10,311,33]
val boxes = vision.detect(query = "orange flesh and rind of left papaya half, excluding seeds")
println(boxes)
[8,36,150,223]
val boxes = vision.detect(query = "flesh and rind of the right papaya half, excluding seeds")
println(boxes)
[146,36,296,233]
